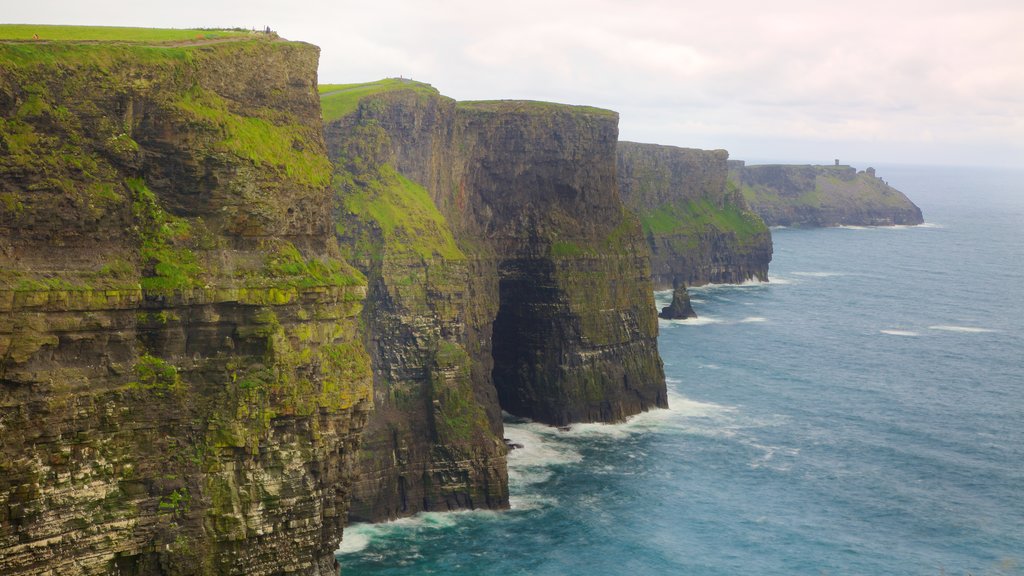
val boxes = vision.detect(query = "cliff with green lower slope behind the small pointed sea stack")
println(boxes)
[616,141,772,289]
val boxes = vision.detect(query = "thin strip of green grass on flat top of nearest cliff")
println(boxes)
[0,24,253,43]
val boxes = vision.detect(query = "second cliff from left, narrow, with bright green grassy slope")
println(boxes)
[322,81,508,521]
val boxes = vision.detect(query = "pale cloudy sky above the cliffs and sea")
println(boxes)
[0,0,1024,168]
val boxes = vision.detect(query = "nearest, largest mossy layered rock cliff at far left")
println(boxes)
[0,39,372,575]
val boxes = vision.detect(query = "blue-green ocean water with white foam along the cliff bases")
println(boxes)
[339,166,1024,576]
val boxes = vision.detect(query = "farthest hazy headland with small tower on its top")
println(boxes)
[729,162,924,227]
